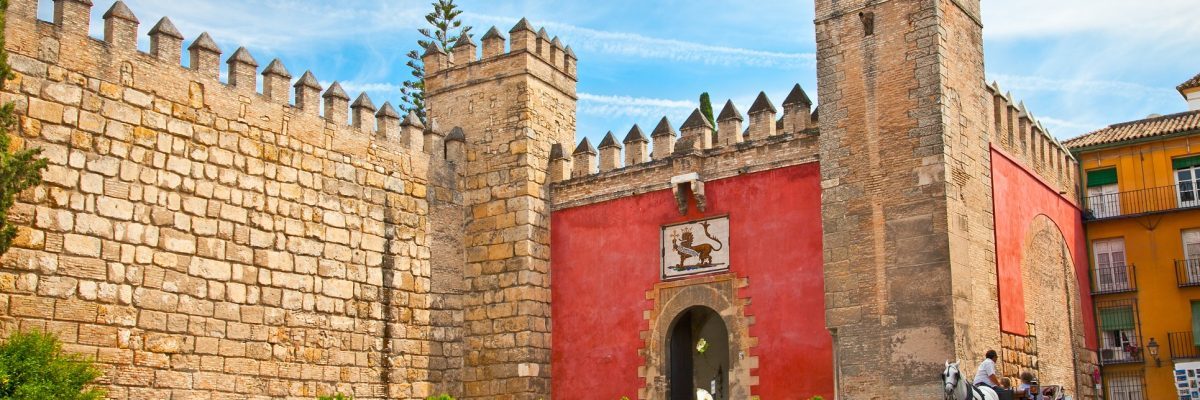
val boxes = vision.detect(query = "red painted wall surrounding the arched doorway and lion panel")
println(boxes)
[551,163,834,399]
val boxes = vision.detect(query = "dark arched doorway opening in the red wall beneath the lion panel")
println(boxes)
[667,306,731,400]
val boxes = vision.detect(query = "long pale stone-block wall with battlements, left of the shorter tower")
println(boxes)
[0,0,475,399]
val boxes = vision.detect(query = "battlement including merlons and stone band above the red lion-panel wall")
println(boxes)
[550,85,820,209]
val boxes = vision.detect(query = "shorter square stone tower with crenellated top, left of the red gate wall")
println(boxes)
[424,19,576,400]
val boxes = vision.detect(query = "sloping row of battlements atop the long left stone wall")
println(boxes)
[8,0,465,164]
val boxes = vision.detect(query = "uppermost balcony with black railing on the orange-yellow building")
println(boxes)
[1084,183,1200,221]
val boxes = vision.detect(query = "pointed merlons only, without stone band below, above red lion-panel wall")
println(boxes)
[550,84,818,183]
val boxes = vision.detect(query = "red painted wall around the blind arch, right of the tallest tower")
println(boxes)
[991,148,1097,348]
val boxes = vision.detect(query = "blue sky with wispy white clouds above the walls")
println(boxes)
[40,0,1200,141]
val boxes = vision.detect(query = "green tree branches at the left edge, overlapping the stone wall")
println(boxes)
[0,0,46,255]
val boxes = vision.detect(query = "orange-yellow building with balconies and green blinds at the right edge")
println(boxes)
[1066,76,1200,400]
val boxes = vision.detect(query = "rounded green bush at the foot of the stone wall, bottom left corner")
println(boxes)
[0,329,104,400]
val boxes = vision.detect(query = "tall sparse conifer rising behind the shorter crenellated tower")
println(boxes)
[401,0,470,123]
